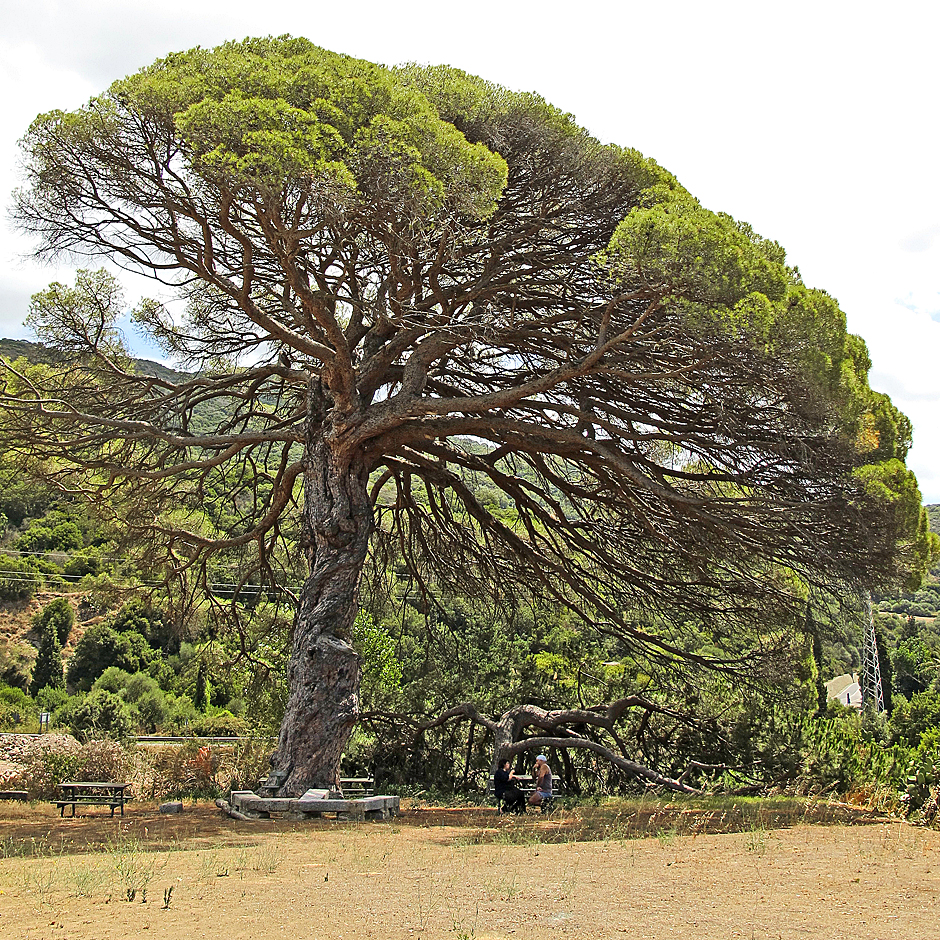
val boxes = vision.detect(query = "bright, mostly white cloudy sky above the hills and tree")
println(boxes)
[0,0,940,502]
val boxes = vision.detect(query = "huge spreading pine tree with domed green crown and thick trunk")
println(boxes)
[3,37,931,793]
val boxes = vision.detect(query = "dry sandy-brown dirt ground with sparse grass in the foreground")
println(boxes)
[0,804,940,940]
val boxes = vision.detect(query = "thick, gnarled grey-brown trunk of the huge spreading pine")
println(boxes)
[271,412,372,796]
